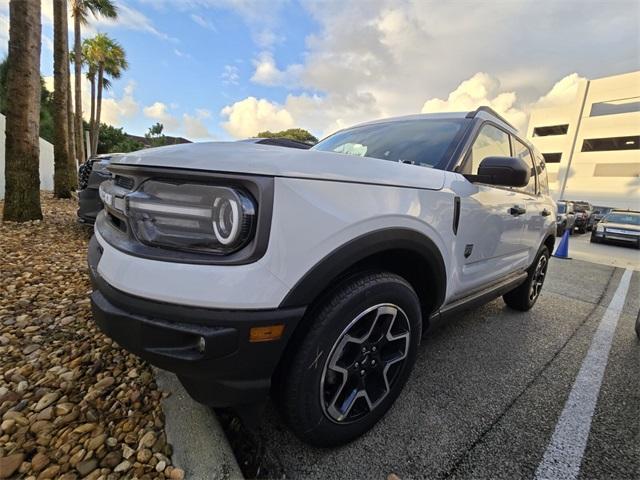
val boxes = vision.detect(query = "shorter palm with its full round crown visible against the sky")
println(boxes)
[84,33,129,155]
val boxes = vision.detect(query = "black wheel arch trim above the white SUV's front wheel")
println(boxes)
[280,228,447,308]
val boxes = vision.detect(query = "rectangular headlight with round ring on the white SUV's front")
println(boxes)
[126,180,256,254]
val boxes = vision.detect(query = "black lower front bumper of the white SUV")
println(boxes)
[88,237,305,407]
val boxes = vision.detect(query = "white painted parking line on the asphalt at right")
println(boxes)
[535,269,633,480]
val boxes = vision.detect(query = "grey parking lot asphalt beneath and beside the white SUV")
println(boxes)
[260,258,640,479]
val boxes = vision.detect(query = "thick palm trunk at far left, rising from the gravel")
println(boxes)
[3,0,42,222]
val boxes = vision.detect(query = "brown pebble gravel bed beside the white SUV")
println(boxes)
[0,193,184,480]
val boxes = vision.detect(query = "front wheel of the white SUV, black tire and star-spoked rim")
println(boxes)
[278,272,422,447]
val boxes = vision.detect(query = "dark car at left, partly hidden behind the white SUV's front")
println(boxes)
[78,153,122,225]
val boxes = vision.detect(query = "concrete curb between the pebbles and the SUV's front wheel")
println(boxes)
[153,367,244,480]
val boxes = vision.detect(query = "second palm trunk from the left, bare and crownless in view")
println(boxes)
[53,0,77,198]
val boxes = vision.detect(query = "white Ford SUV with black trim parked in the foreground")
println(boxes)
[89,107,556,446]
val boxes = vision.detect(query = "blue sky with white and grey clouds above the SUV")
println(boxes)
[0,0,640,140]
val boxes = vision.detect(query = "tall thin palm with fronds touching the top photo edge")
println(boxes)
[71,0,118,162]
